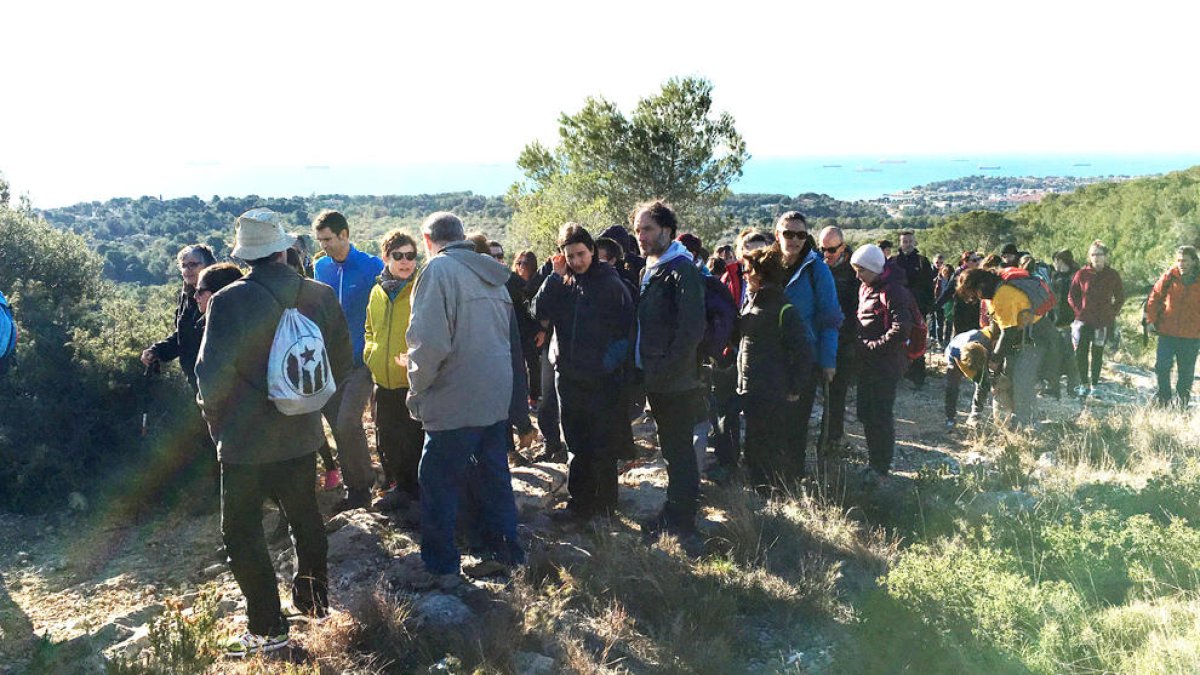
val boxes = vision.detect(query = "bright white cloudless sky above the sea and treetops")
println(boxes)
[0,0,1200,207]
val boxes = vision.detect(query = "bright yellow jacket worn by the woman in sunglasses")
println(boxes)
[362,274,419,389]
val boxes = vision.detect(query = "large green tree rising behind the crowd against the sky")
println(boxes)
[508,78,749,253]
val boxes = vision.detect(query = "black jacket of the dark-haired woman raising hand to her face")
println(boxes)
[532,261,634,386]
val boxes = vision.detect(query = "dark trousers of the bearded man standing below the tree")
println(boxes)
[646,389,702,528]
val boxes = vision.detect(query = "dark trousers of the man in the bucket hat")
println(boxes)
[221,453,329,635]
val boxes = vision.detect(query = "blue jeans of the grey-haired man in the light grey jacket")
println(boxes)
[418,419,524,574]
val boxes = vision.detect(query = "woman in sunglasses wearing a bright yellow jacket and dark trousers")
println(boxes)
[362,229,425,510]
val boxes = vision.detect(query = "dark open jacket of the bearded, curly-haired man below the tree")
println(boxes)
[637,247,704,394]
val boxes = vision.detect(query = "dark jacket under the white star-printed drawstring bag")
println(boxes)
[196,263,354,464]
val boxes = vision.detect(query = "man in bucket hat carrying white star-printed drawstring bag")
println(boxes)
[196,209,353,657]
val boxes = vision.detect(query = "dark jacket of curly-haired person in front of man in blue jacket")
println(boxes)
[738,287,814,401]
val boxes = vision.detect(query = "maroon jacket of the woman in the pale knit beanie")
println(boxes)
[858,261,917,377]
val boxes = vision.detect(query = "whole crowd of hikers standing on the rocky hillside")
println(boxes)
[114,201,1200,656]
